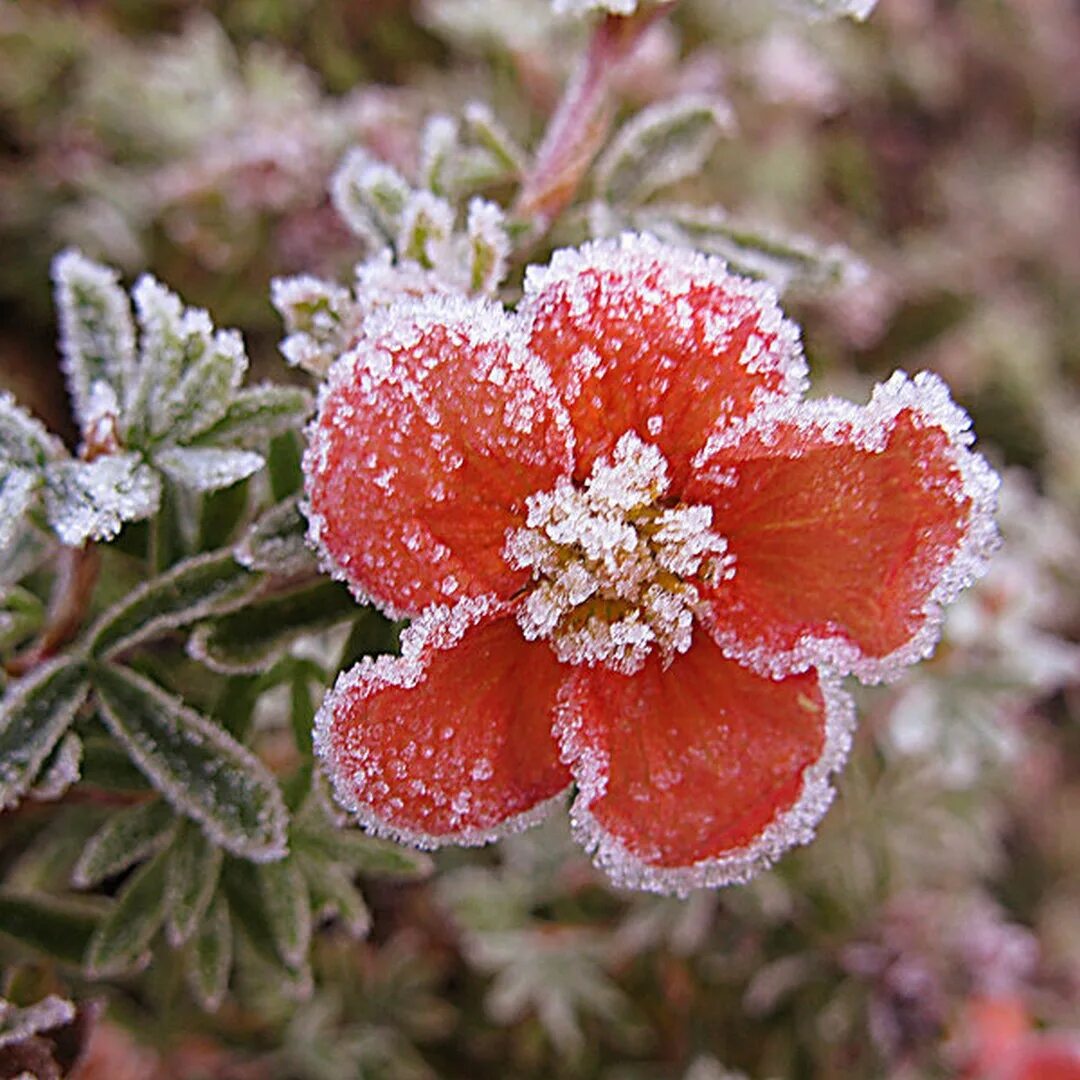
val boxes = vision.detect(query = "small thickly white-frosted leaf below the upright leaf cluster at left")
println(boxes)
[44,454,161,548]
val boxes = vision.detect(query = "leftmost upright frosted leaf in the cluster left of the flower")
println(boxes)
[53,251,135,430]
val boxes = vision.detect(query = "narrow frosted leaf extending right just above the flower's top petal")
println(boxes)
[633,206,865,293]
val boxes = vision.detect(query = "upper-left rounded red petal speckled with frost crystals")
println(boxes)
[305,298,570,613]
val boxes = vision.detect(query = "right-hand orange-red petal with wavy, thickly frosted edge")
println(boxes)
[684,373,998,681]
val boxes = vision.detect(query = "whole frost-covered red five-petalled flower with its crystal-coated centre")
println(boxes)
[306,235,997,892]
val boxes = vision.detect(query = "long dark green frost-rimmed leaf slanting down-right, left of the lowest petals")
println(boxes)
[93,664,288,861]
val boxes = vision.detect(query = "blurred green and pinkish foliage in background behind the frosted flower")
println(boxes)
[0,0,1080,1080]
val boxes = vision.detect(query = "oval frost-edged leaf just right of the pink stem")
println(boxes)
[596,95,731,205]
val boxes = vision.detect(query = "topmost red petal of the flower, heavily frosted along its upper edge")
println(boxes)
[519,233,806,489]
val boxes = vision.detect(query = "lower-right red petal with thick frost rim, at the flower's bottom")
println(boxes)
[555,632,852,895]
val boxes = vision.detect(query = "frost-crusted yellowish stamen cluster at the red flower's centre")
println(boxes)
[503,432,734,674]
